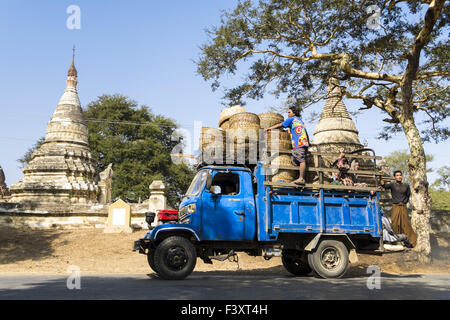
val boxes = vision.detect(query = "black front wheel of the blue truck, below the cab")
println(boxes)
[155,236,197,280]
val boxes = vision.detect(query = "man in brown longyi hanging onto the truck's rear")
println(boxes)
[381,170,417,247]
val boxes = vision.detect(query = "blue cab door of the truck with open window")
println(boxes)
[200,172,245,240]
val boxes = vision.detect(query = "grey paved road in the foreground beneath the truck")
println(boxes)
[0,272,450,300]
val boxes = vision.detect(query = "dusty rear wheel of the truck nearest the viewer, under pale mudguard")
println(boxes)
[308,240,349,278]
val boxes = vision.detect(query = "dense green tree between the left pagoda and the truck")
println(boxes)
[83,95,193,207]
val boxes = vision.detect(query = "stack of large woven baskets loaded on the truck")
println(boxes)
[199,106,297,182]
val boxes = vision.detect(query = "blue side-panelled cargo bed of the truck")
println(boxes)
[256,166,382,241]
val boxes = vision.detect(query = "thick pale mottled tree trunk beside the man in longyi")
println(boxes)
[402,117,431,263]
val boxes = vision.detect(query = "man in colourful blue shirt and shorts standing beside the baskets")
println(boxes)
[266,107,310,184]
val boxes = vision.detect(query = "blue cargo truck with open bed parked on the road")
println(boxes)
[133,163,383,279]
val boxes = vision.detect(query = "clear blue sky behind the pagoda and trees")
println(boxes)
[0,0,450,185]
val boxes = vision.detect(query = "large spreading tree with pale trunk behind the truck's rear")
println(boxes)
[197,0,450,262]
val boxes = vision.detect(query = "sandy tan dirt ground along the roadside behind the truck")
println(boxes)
[0,227,450,276]
